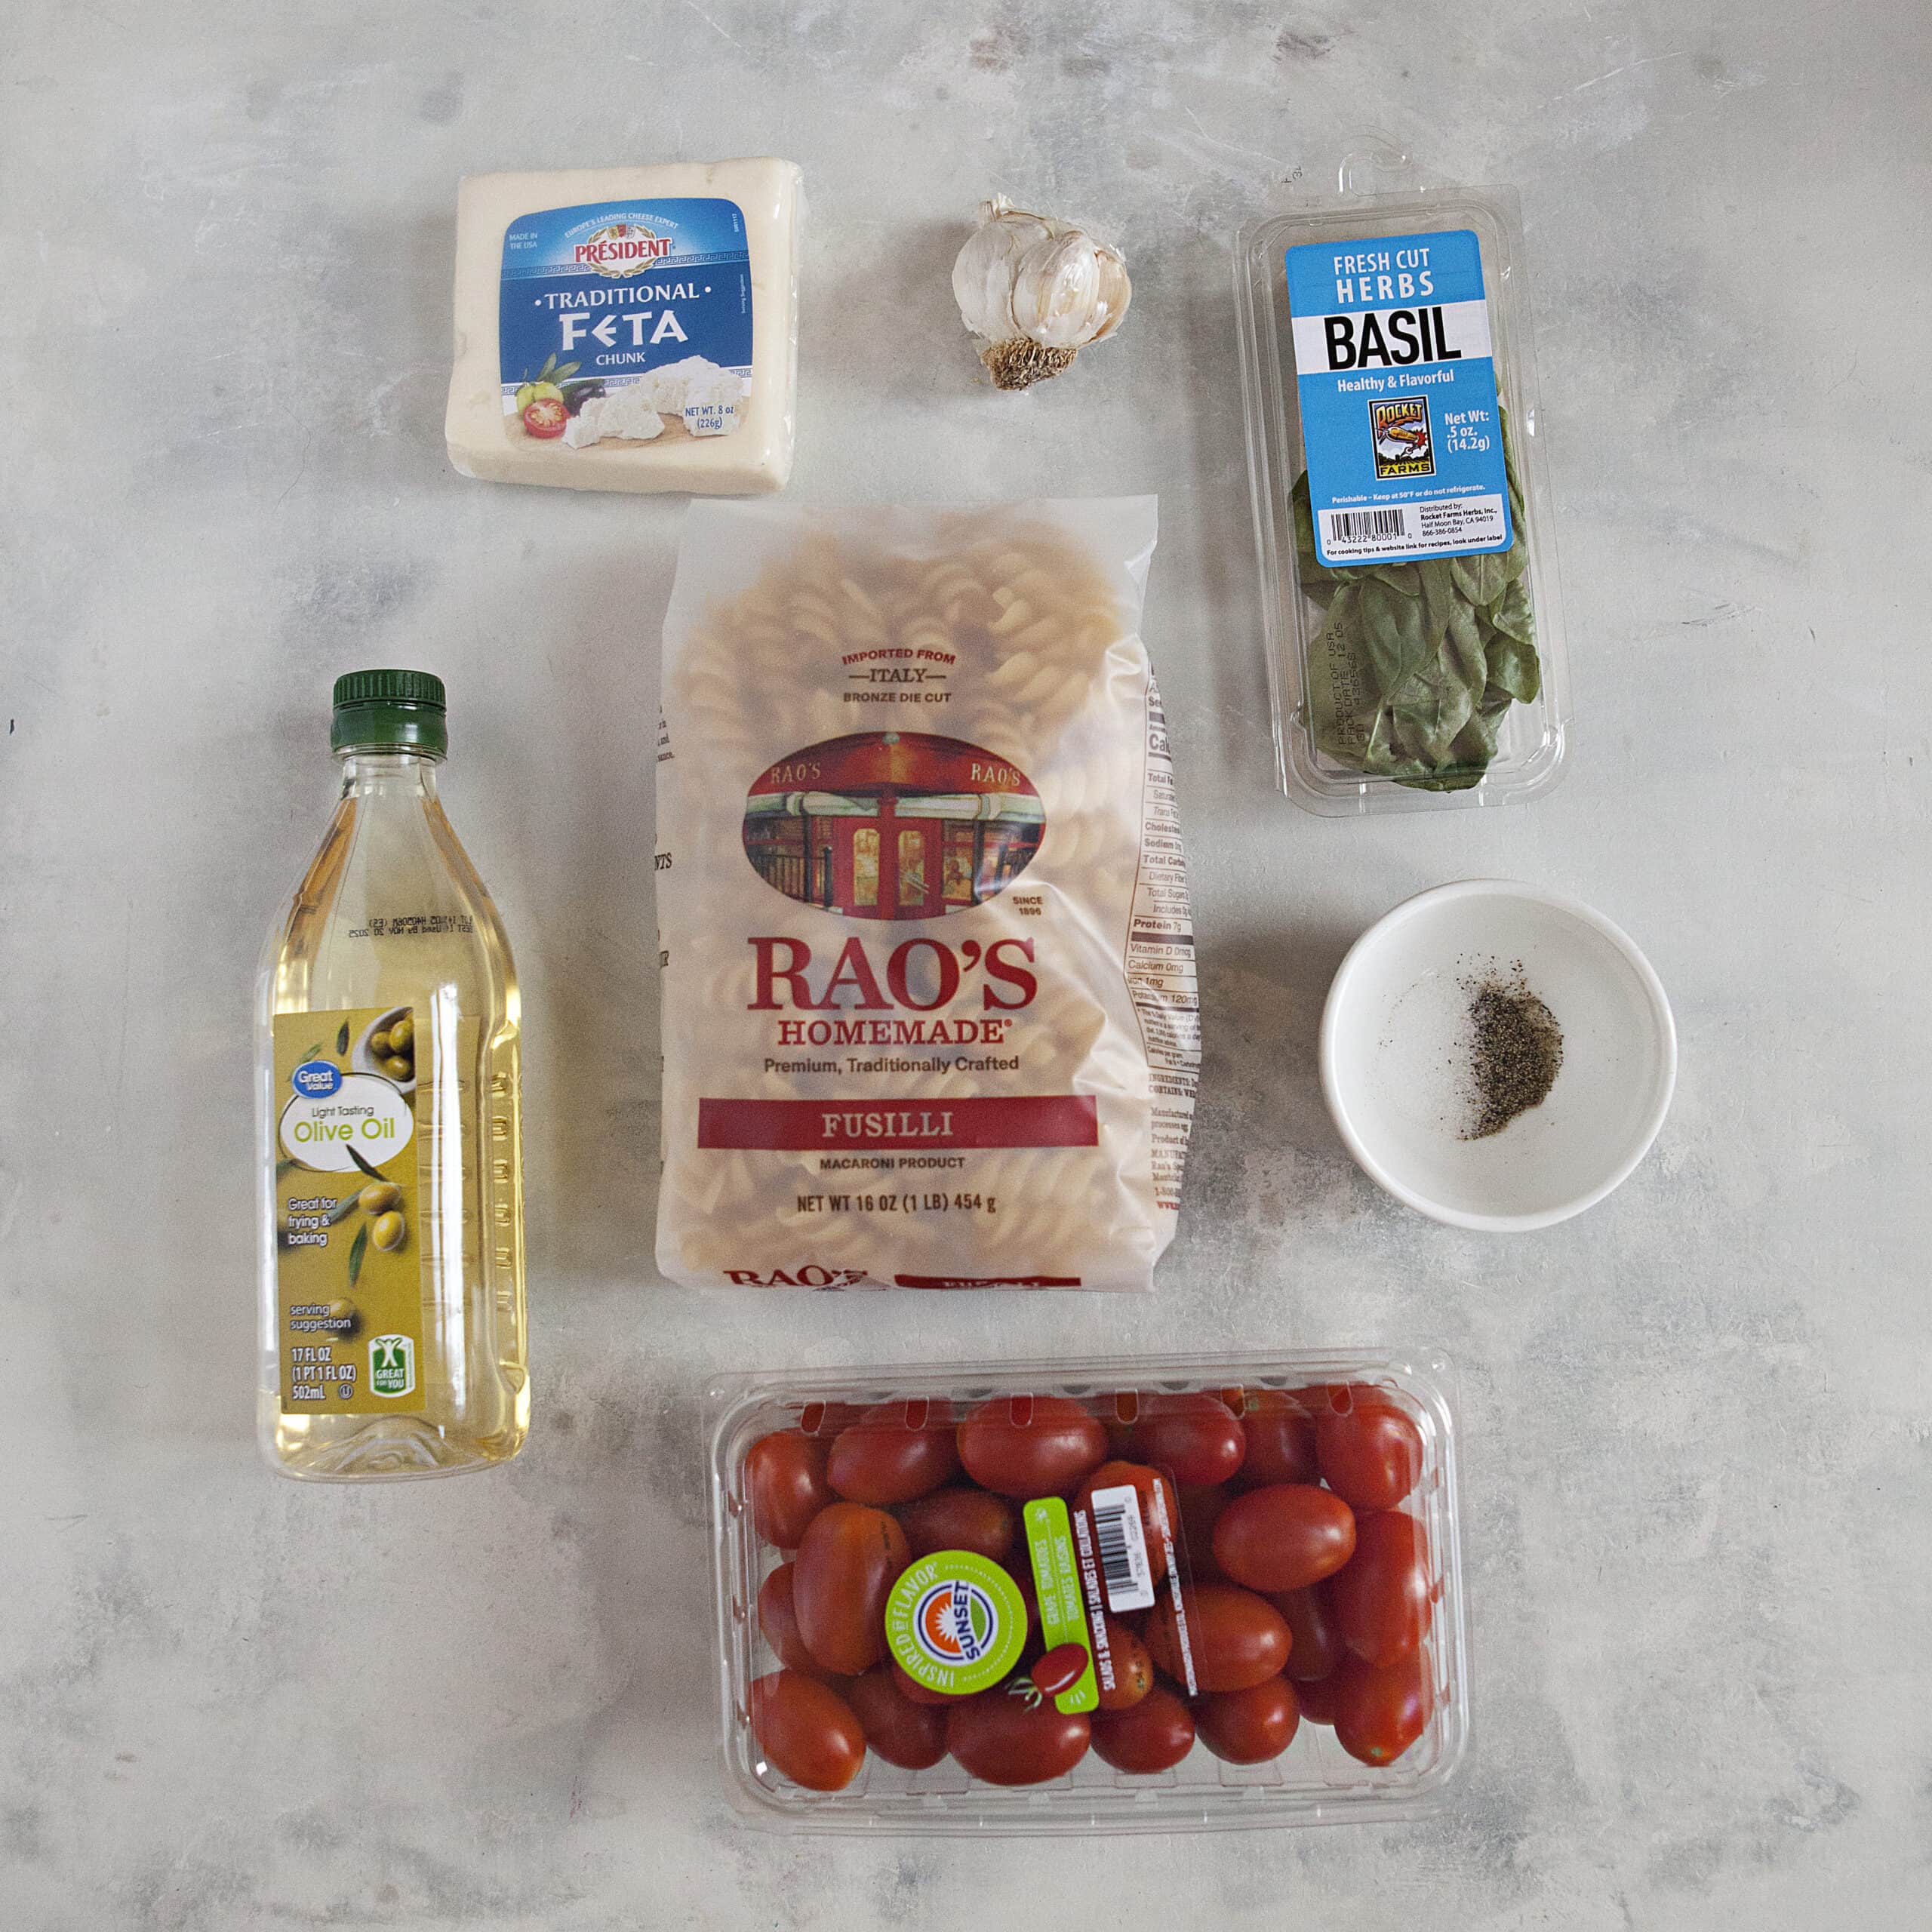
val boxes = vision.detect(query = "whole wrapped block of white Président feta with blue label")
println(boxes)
[445,158,804,497]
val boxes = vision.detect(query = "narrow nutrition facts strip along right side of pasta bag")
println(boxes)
[1126,684,1201,1210]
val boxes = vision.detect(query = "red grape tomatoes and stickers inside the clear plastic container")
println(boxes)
[736,1383,1441,1791]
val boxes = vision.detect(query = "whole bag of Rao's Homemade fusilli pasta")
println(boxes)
[657,497,1200,1289]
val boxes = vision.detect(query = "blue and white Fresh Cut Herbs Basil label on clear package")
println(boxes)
[1287,228,1512,570]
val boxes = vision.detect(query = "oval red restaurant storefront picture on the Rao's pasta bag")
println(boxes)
[744,731,1045,920]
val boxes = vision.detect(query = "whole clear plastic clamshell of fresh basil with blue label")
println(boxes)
[1236,166,1567,817]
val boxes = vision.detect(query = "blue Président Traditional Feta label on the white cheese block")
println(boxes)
[497,197,752,446]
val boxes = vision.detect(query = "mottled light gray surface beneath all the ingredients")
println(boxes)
[0,0,1932,1932]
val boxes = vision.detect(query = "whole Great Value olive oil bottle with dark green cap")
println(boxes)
[257,670,529,1482]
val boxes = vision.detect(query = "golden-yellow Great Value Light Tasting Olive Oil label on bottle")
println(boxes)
[275,1007,435,1416]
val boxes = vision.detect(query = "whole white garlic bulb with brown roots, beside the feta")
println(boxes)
[952,195,1132,389]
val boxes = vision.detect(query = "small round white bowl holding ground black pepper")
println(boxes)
[1321,879,1677,1232]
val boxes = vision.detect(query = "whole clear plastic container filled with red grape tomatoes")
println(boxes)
[709,1350,1469,1833]
